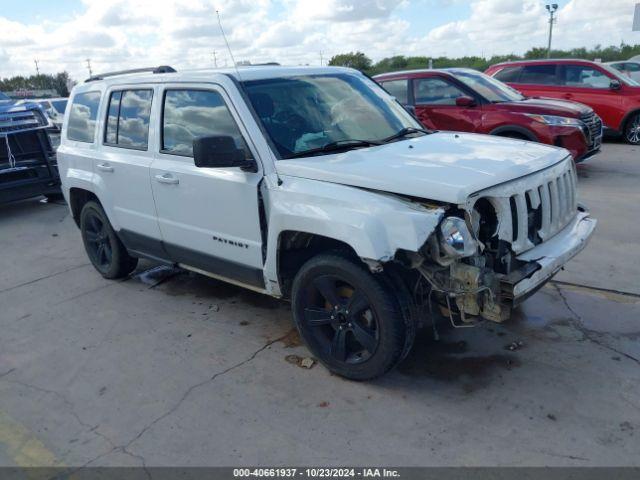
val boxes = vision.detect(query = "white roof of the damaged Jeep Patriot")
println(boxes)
[76,65,358,91]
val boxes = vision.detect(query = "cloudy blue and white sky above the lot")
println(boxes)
[0,0,640,79]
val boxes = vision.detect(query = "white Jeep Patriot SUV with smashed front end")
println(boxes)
[58,66,596,379]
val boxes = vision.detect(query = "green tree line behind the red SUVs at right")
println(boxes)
[329,43,640,75]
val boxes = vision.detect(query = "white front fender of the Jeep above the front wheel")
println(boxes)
[265,176,444,295]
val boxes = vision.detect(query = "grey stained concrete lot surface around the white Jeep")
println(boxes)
[0,143,640,466]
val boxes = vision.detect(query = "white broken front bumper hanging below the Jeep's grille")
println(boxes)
[502,211,597,306]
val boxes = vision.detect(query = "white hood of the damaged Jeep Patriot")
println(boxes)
[276,132,568,205]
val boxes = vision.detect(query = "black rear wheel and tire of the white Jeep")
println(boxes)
[80,202,138,279]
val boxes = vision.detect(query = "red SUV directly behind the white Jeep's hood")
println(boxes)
[374,68,602,162]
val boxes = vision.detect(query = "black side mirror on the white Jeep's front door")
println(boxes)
[193,135,258,172]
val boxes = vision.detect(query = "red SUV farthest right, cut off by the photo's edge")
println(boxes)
[486,59,640,145]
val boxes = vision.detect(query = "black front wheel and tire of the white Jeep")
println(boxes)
[292,254,414,380]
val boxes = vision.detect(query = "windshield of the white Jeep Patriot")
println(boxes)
[243,73,421,159]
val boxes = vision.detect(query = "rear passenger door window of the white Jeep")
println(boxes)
[104,89,153,150]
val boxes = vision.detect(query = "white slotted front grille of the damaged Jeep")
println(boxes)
[471,157,578,254]
